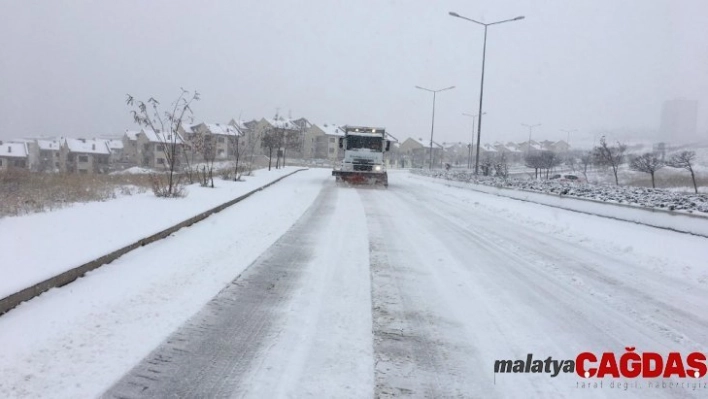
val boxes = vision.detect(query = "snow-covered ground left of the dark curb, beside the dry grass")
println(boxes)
[0,167,297,298]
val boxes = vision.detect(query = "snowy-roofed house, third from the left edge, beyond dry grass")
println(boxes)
[59,138,111,174]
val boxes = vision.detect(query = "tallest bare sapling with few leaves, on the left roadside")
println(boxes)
[126,89,199,197]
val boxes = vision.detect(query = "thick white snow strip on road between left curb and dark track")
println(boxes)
[0,170,332,398]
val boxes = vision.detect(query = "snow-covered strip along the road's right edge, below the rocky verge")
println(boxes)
[410,173,708,238]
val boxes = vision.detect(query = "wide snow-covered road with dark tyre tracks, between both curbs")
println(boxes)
[0,170,708,398]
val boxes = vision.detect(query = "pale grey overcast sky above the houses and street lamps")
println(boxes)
[0,0,708,147]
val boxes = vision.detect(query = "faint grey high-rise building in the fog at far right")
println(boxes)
[661,99,700,143]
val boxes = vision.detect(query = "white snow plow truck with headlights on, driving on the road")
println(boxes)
[332,126,391,187]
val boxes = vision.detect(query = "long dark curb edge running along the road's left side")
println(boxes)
[0,168,308,316]
